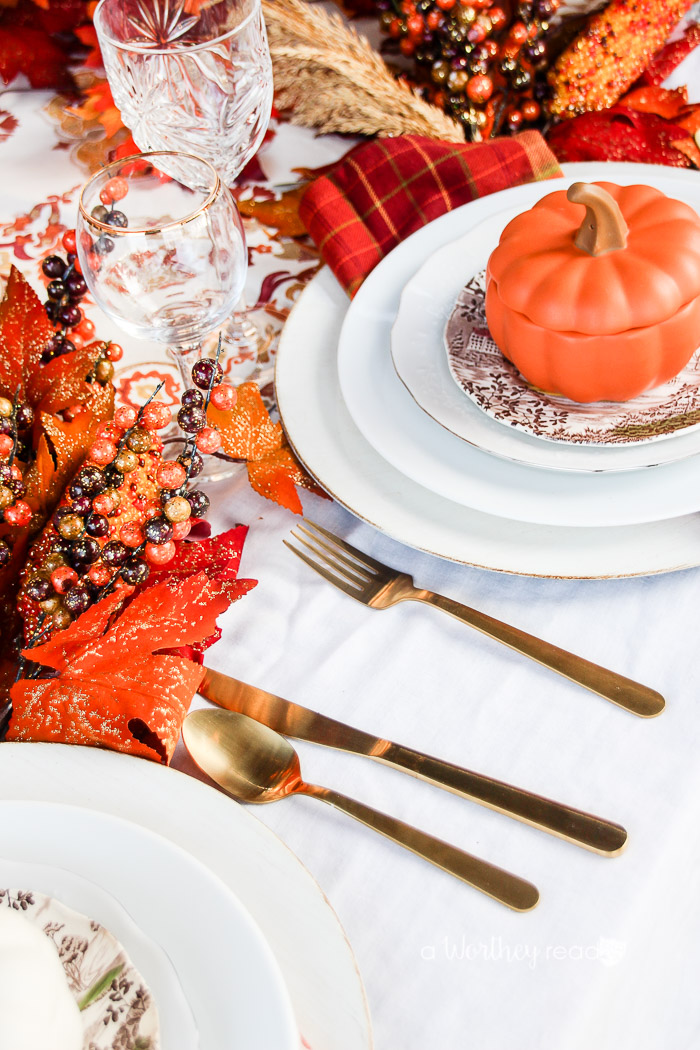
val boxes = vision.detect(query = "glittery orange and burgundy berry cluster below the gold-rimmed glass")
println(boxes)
[22,344,236,630]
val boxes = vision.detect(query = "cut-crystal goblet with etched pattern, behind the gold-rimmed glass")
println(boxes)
[94,0,272,185]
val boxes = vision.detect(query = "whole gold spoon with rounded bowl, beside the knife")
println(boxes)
[183,711,539,911]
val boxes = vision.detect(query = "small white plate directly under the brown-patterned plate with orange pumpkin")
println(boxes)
[391,213,700,471]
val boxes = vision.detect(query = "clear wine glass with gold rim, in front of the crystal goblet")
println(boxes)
[77,152,248,459]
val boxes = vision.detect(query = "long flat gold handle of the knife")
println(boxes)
[384,743,628,857]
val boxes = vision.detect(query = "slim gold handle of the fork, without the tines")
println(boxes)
[419,590,665,718]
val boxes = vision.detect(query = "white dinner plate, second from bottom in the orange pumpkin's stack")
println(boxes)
[338,164,700,527]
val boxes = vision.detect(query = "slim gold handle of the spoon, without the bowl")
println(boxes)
[304,783,539,911]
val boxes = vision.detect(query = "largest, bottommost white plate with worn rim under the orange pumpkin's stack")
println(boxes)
[276,259,700,579]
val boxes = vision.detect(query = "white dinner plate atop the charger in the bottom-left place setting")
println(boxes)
[0,797,299,1050]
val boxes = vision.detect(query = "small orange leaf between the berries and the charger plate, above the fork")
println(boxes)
[208,382,325,515]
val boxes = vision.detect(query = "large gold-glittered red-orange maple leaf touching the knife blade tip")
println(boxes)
[7,572,238,762]
